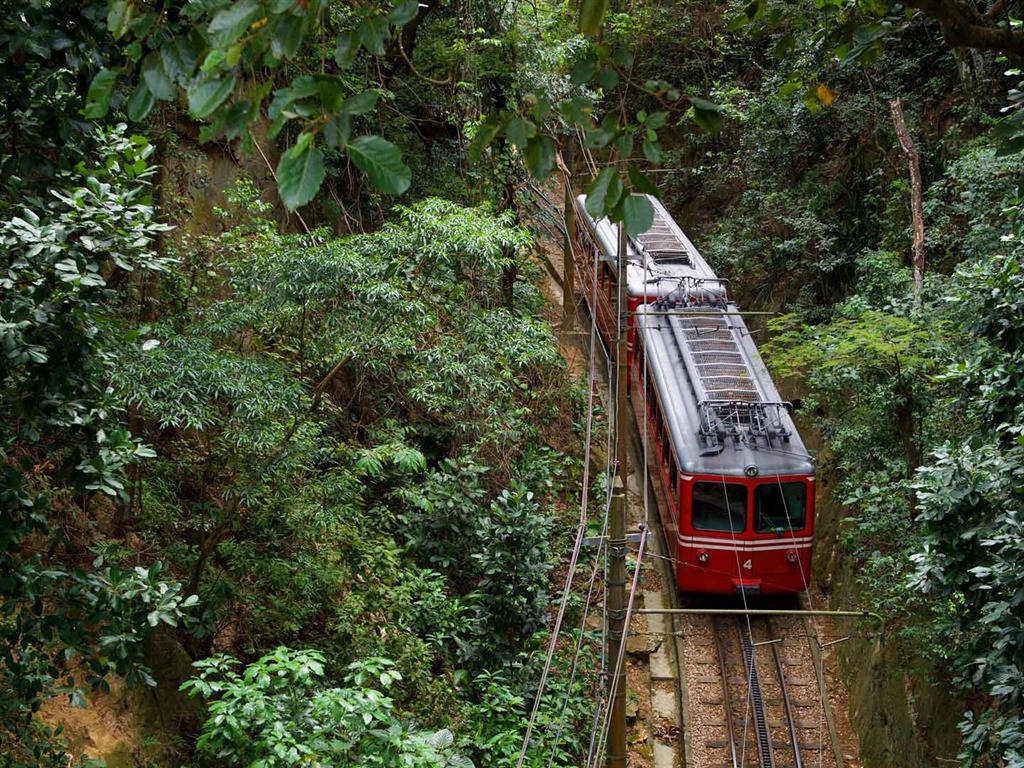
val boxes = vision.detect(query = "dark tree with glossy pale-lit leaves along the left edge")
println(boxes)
[0,126,197,765]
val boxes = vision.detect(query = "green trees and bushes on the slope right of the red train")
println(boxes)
[766,185,1024,765]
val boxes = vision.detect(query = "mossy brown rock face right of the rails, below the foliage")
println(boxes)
[814,478,967,768]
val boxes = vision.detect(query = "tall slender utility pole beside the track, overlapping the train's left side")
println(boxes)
[605,224,629,768]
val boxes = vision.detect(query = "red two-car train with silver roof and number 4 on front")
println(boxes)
[571,195,815,597]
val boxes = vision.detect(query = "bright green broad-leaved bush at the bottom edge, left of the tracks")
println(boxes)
[181,647,473,768]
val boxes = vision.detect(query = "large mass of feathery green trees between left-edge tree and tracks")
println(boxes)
[99,188,589,761]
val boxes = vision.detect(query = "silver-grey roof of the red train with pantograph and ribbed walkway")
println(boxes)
[577,195,814,477]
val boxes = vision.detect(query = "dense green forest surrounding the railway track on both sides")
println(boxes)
[6,0,1024,768]
